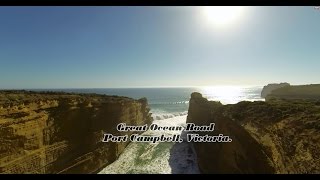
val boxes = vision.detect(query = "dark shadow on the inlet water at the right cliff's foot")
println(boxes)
[169,131,200,174]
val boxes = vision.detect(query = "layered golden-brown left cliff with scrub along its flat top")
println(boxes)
[0,91,152,173]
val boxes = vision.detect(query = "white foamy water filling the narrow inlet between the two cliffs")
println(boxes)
[99,115,199,174]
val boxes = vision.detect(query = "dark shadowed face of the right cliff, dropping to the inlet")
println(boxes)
[187,93,274,173]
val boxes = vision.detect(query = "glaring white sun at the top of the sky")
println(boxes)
[203,6,245,27]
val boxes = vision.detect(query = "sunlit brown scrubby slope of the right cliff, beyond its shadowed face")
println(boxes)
[224,100,320,173]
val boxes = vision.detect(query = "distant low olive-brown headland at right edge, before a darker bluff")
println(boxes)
[265,84,320,101]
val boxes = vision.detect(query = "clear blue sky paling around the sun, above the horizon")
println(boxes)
[0,6,320,89]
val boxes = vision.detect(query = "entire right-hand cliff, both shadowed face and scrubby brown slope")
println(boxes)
[187,93,320,173]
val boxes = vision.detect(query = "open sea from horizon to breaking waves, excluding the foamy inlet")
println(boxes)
[33,86,264,120]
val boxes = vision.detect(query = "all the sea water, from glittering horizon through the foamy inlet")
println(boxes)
[31,86,264,174]
